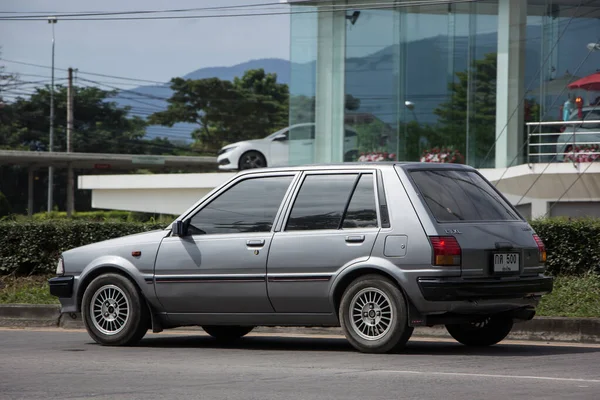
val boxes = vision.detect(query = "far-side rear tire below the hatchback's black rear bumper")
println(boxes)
[446,316,513,347]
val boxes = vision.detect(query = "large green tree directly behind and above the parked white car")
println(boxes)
[149,69,288,153]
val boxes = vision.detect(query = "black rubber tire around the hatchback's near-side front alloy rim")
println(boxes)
[81,273,150,346]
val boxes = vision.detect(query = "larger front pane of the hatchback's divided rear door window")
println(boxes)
[286,174,357,231]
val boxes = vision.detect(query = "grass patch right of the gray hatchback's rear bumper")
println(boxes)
[536,274,600,318]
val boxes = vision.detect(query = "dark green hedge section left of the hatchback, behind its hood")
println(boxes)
[0,220,166,275]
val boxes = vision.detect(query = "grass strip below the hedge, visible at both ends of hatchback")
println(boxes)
[0,275,600,318]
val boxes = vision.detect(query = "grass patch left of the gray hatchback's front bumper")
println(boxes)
[0,275,59,304]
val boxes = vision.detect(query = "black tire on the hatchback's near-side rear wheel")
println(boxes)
[339,275,413,353]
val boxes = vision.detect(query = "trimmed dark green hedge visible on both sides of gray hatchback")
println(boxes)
[0,216,600,276]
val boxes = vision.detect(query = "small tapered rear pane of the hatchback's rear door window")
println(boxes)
[342,174,377,228]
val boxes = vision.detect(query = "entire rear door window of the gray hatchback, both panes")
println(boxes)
[285,174,377,231]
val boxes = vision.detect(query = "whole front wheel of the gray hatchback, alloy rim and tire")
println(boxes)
[81,274,150,346]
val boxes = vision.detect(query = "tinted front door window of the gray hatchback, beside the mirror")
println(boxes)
[189,175,294,235]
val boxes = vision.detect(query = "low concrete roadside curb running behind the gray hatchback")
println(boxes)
[0,304,600,344]
